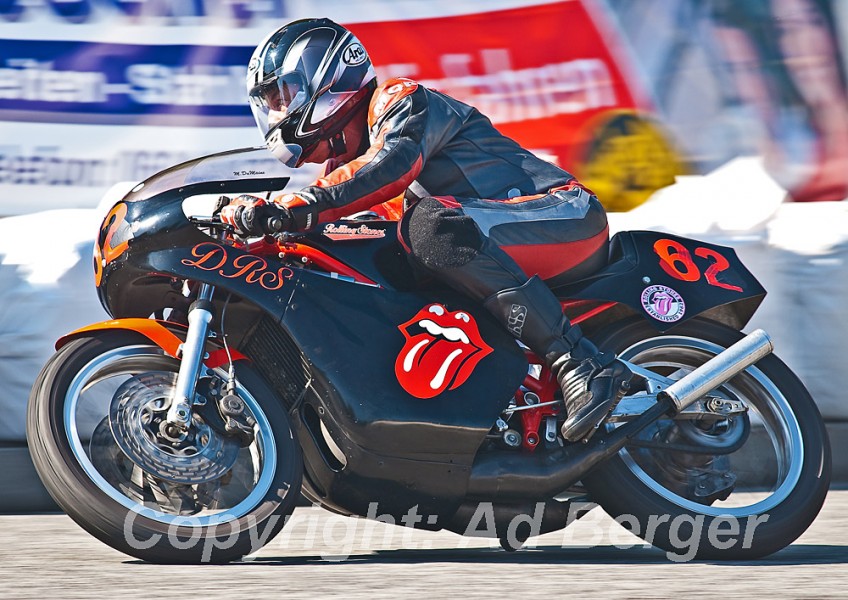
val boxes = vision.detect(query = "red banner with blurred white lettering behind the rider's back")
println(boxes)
[350,1,635,159]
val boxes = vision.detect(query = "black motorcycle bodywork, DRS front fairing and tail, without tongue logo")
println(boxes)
[71,152,765,518]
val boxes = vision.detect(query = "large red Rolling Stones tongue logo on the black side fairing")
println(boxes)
[395,304,492,398]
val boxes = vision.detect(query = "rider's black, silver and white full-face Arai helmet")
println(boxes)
[247,19,377,167]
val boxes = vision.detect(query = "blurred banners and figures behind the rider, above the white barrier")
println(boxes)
[0,0,848,215]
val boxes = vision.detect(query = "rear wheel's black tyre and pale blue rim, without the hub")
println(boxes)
[583,319,831,560]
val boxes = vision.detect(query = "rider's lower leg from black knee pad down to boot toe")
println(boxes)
[399,198,632,441]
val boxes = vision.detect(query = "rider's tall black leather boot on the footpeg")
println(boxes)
[484,276,633,442]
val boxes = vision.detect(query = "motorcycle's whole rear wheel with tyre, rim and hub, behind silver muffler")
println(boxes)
[583,319,831,560]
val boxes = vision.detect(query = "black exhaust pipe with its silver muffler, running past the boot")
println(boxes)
[467,329,774,503]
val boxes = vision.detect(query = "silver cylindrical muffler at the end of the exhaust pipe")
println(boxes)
[657,329,774,414]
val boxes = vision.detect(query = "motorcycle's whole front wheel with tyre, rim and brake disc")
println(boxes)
[27,331,303,563]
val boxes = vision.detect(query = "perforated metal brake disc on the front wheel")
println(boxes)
[109,372,240,485]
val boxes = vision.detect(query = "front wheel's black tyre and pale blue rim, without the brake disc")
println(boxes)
[27,331,303,563]
